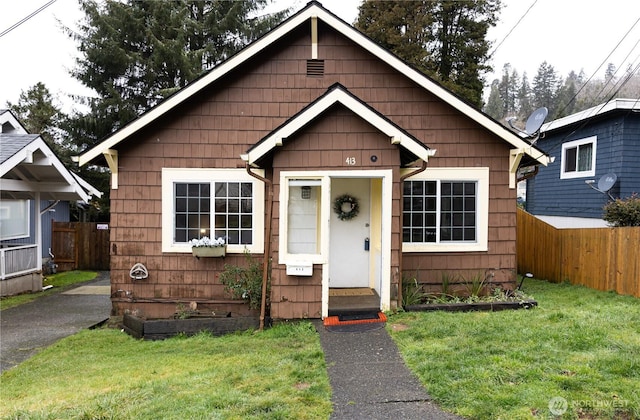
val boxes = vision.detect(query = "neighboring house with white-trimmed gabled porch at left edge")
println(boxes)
[0,110,102,296]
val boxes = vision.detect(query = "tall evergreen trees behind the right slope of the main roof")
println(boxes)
[356,0,500,106]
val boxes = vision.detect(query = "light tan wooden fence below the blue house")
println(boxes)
[517,209,640,297]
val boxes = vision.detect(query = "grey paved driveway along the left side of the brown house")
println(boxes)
[0,272,111,372]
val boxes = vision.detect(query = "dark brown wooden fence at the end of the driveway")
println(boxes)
[51,222,110,271]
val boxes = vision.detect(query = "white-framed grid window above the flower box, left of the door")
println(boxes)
[162,169,264,252]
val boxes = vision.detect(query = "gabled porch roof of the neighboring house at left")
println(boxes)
[0,133,102,202]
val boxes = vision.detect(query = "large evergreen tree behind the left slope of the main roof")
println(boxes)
[68,0,284,147]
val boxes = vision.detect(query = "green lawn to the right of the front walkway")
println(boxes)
[388,280,640,419]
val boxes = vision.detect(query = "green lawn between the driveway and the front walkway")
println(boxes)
[0,322,331,419]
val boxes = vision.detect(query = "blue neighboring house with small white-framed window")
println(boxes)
[525,99,640,228]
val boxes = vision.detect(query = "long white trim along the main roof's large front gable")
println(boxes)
[77,1,550,166]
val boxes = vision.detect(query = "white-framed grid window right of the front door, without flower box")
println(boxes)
[402,168,489,252]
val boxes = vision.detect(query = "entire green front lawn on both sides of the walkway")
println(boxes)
[0,280,640,419]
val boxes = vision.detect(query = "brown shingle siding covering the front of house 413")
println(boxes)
[102,15,516,318]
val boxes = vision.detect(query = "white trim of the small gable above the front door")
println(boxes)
[242,83,435,165]
